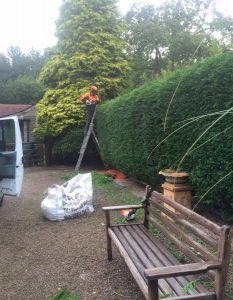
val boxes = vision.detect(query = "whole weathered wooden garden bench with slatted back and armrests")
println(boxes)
[103,186,230,300]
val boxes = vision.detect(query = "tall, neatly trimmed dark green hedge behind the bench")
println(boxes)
[97,53,233,219]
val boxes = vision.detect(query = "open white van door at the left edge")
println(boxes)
[0,116,24,206]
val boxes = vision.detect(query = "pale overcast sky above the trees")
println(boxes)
[0,0,233,53]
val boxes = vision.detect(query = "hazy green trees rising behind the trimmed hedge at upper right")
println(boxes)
[126,0,233,85]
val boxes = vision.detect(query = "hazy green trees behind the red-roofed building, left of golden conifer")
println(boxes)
[0,47,44,104]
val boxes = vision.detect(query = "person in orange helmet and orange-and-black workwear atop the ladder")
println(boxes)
[80,85,100,134]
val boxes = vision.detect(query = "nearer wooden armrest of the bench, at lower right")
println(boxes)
[144,261,221,280]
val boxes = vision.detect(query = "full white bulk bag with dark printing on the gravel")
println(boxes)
[41,173,94,220]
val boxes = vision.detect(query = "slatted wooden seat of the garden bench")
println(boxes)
[109,225,209,299]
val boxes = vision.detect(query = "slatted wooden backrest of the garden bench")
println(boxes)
[144,187,230,298]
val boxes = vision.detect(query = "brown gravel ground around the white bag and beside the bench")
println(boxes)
[0,167,144,300]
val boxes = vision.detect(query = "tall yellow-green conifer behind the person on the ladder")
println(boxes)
[36,0,129,136]
